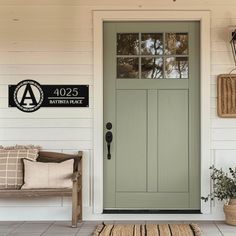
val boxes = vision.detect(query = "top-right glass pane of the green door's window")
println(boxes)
[165,33,188,55]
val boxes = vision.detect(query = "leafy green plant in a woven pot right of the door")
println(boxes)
[201,166,236,226]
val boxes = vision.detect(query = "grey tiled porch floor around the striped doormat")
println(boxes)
[0,221,236,236]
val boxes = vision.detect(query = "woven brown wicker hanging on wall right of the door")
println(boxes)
[217,74,236,118]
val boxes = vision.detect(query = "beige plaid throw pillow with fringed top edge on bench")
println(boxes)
[0,149,38,189]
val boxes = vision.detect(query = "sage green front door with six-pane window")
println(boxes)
[103,22,200,209]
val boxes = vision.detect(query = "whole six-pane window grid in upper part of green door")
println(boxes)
[116,33,189,79]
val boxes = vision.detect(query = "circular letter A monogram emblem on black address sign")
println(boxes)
[14,80,44,112]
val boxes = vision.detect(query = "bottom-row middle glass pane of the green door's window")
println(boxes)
[141,57,163,79]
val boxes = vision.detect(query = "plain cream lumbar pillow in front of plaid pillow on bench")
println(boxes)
[22,159,74,189]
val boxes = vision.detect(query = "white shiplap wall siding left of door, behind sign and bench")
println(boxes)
[0,4,93,220]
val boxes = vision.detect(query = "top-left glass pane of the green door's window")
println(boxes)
[117,33,139,55]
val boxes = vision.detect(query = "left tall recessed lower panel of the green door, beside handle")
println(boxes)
[115,90,147,192]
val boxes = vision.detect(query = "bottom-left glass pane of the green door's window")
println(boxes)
[117,57,139,79]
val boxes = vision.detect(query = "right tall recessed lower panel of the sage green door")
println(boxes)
[157,90,189,192]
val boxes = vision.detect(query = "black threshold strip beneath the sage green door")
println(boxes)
[103,209,201,214]
